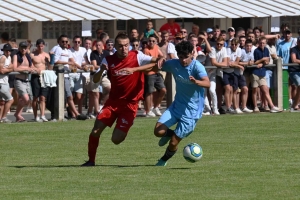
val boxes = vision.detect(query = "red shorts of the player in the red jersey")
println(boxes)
[97,99,138,133]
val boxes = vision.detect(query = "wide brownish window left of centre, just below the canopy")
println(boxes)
[43,21,82,39]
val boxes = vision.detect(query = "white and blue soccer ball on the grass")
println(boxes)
[183,143,203,163]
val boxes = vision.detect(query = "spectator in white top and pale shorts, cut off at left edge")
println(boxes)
[0,44,14,123]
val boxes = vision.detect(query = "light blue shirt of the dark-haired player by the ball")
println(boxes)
[162,59,207,119]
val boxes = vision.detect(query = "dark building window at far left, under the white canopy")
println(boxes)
[0,22,24,39]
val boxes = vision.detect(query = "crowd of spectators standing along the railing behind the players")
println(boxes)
[0,19,300,123]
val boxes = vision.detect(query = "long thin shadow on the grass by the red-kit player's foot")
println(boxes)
[8,164,155,169]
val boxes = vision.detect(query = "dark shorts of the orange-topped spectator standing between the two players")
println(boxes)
[144,73,166,94]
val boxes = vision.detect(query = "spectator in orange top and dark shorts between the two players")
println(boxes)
[144,35,166,117]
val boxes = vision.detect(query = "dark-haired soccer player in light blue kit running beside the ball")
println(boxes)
[154,41,210,166]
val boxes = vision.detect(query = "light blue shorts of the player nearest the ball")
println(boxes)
[158,108,198,138]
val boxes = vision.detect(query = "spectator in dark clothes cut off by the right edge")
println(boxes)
[288,37,300,112]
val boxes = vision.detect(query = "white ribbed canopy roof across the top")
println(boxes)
[0,0,300,21]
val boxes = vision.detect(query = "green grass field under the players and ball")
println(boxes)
[0,113,300,200]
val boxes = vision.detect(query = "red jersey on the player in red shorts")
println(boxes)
[105,51,144,101]
